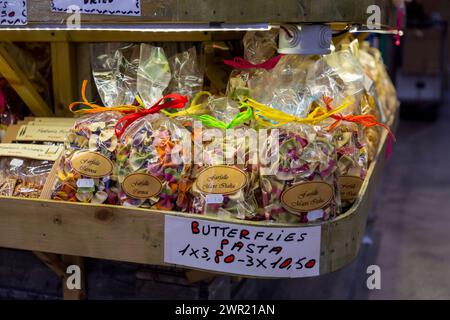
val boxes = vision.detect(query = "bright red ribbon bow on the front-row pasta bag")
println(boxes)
[115,93,189,139]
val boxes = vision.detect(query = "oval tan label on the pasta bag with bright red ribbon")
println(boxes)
[122,173,162,199]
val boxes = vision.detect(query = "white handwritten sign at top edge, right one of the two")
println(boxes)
[52,0,141,16]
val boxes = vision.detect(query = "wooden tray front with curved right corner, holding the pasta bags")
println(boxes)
[0,112,396,274]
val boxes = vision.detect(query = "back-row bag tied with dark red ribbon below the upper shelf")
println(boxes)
[224,30,281,101]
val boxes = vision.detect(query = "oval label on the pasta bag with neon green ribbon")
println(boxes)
[195,166,247,194]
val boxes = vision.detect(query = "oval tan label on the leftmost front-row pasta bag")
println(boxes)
[71,151,113,178]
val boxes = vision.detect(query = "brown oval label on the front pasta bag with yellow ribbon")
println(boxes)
[281,182,333,212]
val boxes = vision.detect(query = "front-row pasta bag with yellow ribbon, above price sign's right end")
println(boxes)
[246,99,345,224]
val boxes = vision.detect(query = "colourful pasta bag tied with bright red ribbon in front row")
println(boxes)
[116,94,191,211]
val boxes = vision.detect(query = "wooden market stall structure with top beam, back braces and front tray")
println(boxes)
[0,0,396,298]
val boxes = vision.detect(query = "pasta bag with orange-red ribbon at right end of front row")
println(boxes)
[311,50,374,210]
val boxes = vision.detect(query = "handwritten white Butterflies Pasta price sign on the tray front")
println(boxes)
[164,215,321,278]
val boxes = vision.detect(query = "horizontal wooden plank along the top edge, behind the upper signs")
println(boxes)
[0,0,392,27]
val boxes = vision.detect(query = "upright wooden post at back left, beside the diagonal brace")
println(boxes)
[50,42,77,116]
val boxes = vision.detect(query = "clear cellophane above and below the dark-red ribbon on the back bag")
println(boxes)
[227,30,278,100]
